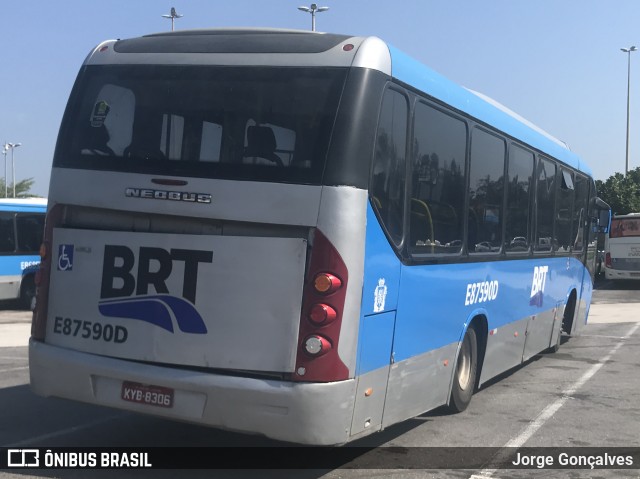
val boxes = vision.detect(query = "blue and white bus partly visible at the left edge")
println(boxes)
[0,198,47,309]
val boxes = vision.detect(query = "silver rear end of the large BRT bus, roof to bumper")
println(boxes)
[30,30,389,444]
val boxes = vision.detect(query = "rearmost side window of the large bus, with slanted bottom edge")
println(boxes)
[370,90,408,246]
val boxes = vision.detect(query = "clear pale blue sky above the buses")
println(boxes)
[0,0,640,196]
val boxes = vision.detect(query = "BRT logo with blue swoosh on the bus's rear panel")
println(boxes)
[99,245,213,334]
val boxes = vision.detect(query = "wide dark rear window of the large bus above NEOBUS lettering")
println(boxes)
[54,65,346,184]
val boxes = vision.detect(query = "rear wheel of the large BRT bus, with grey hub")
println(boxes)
[449,326,478,412]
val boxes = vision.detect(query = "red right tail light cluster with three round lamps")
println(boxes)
[292,229,349,382]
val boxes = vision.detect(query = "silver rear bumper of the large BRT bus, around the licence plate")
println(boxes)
[29,339,356,445]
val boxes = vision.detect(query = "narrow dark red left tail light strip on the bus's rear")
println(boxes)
[31,205,64,341]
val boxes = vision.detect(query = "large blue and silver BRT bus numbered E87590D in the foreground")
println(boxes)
[30,29,602,444]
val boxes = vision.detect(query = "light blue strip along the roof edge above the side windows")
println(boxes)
[388,45,592,176]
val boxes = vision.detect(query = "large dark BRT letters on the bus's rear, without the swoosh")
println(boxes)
[100,245,213,303]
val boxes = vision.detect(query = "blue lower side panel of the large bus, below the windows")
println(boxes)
[356,204,592,375]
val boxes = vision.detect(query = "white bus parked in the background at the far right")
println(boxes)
[604,213,640,279]
